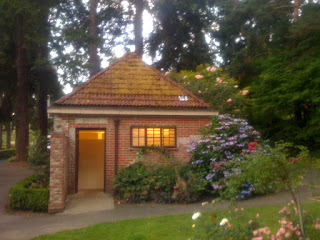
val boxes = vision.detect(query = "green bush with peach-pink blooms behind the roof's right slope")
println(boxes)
[170,65,245,115]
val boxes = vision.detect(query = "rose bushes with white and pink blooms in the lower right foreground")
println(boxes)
[192,201,320,240]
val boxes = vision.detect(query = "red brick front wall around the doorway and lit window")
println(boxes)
[51,115,210,199]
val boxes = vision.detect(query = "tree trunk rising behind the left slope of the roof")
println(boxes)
[89,0,100,77]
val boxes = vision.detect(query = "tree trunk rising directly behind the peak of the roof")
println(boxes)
[134,0,143,57]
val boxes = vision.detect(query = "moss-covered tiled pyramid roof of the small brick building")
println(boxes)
[55,53,209,109]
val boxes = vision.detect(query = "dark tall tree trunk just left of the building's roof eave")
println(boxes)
[38,1,50,151]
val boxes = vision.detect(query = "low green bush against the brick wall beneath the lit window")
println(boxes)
[114,162,203,203]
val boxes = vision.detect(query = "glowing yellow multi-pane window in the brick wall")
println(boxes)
[131,127,176,147]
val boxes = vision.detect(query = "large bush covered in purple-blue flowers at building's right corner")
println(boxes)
[188,115,260,198]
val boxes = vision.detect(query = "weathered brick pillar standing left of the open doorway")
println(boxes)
[48,133,68,213]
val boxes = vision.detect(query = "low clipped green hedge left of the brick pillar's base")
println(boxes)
[8,175,49,212]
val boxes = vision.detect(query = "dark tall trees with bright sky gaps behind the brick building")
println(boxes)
[0,0,320,161]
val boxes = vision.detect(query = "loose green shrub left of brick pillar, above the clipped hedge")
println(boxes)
[28,135,50,176]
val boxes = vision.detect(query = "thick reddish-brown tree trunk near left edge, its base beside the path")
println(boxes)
[16,19,29,162]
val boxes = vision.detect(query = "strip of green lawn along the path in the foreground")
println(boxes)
[33,202,320,240]
